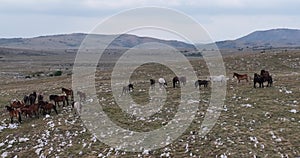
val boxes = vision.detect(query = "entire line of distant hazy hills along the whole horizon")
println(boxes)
[0,29,300,51]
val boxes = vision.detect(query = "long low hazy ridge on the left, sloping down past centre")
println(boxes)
[0,33,195,50]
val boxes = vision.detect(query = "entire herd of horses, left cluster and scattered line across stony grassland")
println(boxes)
[5,70,273,123]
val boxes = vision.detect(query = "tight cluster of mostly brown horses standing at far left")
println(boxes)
[5,88,86,123]
